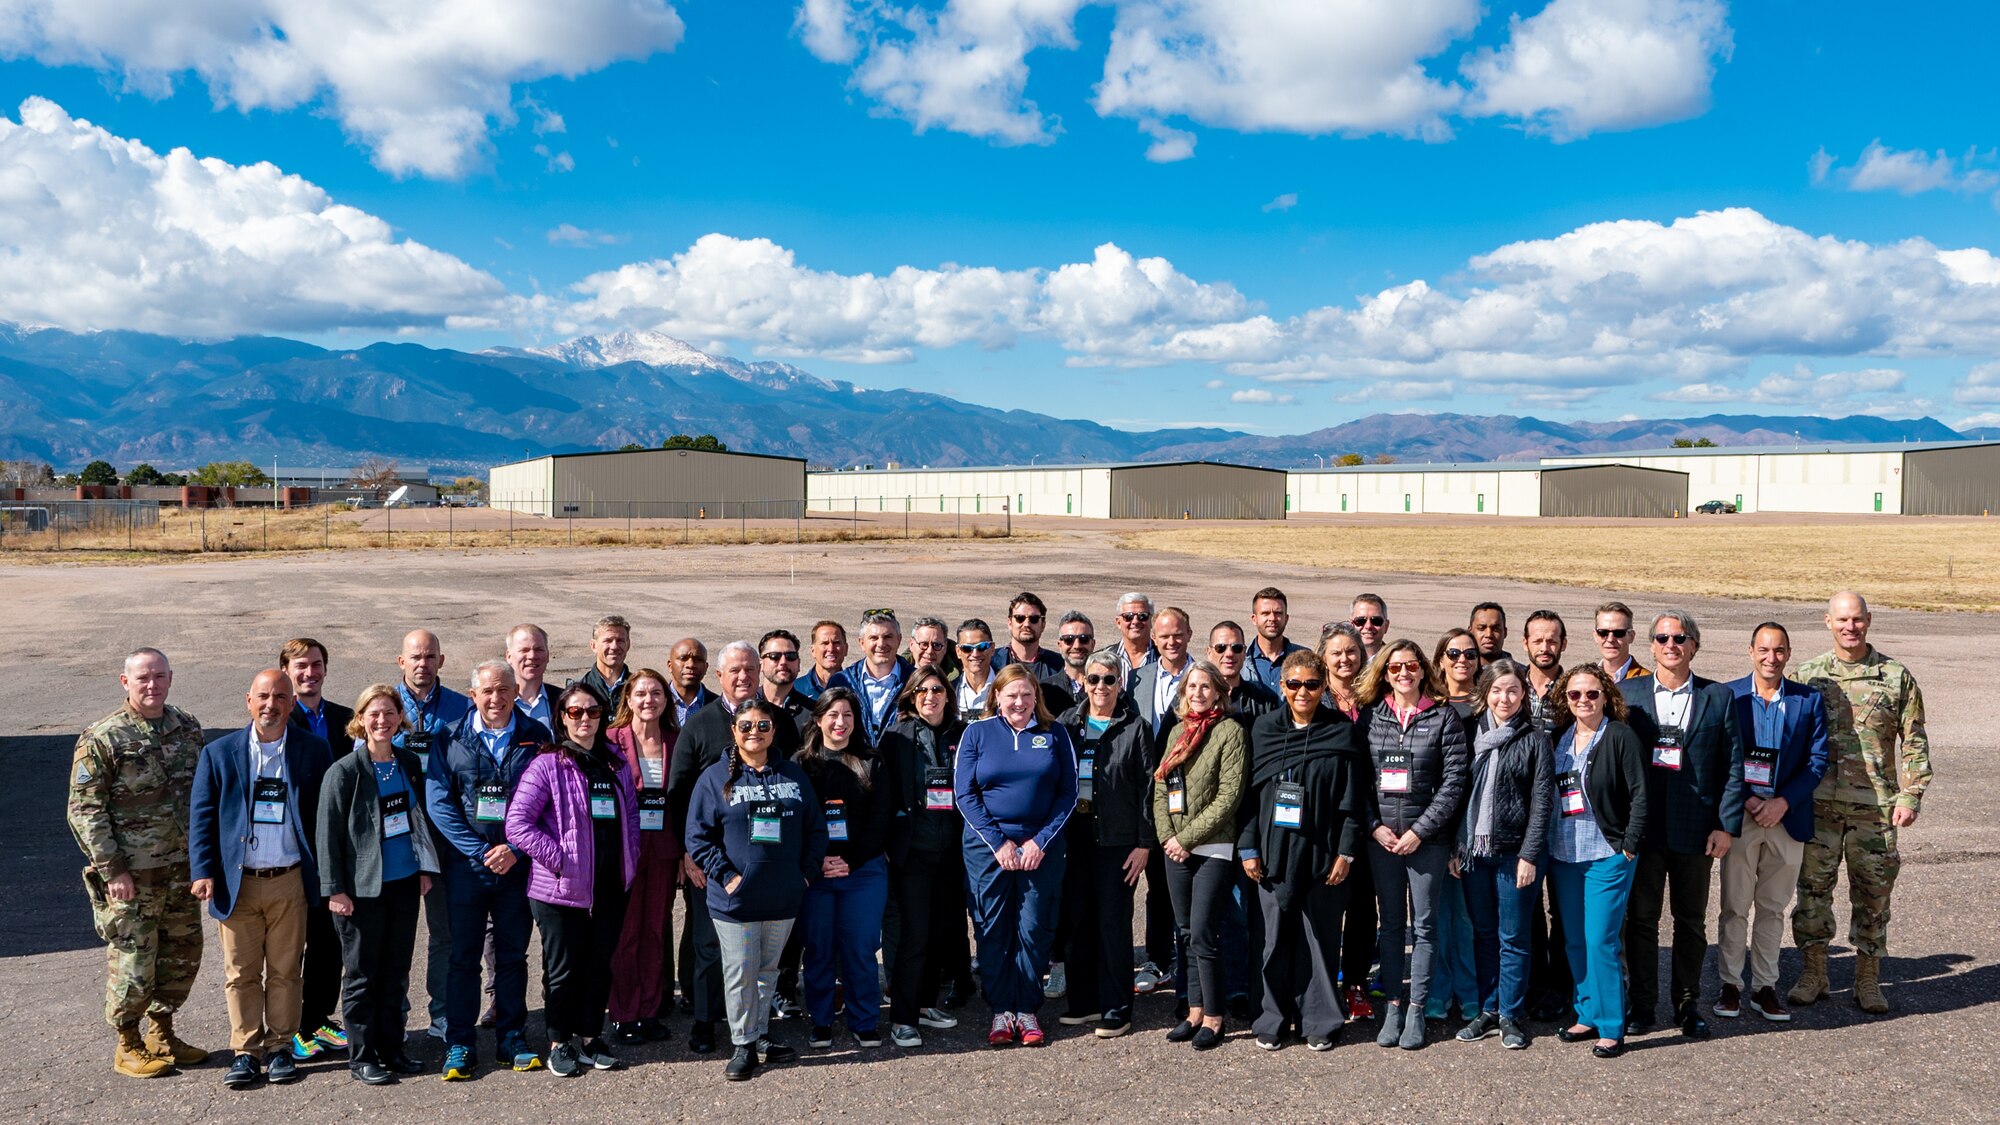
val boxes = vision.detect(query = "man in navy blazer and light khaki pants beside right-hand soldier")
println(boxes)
[1716,621,1828,1023]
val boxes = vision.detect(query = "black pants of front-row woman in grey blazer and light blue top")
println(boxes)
[332,875,424,1067]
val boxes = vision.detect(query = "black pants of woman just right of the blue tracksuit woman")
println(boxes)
[1060,813,1132,1015]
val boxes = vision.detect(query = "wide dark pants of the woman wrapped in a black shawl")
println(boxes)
[1256,876,1360,1041]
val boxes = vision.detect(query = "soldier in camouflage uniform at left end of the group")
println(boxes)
[68,649,208,1079]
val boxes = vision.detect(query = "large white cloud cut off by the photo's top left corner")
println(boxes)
[0,0,682,176]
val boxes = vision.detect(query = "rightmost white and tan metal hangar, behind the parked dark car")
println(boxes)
[1542,440,2000,516]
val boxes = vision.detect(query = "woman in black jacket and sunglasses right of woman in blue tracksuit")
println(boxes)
[1062,651,1154,1039]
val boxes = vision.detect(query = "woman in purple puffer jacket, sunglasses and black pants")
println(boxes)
[506,683,638,1077]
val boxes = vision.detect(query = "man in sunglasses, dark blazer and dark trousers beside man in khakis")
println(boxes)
[1618,609,1744,1039]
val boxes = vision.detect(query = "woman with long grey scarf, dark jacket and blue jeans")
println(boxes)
[1452,659,1556,1051]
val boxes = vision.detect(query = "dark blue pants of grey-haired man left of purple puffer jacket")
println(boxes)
[444,855,534,1049]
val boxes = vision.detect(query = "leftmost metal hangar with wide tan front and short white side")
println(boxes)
[488,448,806,518]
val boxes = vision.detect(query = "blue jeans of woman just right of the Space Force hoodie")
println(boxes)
[798,855,888,1031]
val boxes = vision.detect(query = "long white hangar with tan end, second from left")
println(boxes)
[806,460,1286,520]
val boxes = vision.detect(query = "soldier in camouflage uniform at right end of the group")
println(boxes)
[1788,593,1930,1015]
